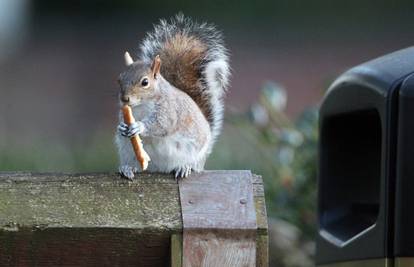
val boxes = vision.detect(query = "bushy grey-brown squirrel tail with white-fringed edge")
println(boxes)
[139,14,230,150]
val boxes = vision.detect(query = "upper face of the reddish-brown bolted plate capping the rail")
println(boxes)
[179,171,257,230]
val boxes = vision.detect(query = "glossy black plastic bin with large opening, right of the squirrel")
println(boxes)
[316,47,414,265]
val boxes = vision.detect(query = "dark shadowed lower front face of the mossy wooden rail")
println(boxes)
[0,228,169,267]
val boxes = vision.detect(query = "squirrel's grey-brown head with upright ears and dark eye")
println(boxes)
[118,52,161,106]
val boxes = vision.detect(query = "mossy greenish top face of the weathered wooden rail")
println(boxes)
[0,173,182,232]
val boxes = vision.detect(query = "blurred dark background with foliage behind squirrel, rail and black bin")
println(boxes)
[0,0,414,266]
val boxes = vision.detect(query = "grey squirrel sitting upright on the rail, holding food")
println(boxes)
[115,13,230,179]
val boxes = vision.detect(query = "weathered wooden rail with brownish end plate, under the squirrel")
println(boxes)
[0,171,268,266]
